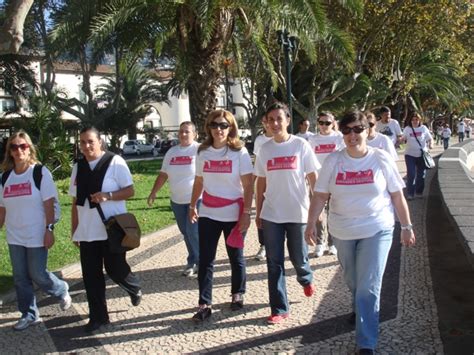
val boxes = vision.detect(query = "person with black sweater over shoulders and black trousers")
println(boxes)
[69,127,142,332]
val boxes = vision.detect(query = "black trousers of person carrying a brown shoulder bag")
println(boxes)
[80,240,140,322]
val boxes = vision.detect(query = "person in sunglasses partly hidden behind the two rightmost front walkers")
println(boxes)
[309,112,344,258]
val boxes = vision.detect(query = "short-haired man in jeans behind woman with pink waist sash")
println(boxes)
[148,121,199,277]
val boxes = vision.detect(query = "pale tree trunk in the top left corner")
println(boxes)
[0,0,33,55]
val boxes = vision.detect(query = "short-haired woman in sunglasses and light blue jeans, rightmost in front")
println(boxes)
[305,111,415,354]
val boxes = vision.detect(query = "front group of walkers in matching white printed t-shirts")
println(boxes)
[0,102,423,353]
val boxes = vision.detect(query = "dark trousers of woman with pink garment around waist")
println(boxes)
[198,217,246,305]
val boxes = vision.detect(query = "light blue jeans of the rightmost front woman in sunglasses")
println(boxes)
[334,229,393,349]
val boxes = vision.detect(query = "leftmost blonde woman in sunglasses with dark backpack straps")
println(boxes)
[0,131,71,330]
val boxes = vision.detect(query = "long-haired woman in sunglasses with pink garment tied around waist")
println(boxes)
[189,110,253,322]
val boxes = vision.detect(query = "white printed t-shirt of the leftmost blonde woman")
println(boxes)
[0,165,58,248]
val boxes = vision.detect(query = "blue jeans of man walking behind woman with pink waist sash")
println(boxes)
[170,201,201,267]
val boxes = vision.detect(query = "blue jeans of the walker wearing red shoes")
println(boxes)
[262,220,313,315]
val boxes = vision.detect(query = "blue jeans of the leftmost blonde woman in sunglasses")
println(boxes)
[8,244,67,320]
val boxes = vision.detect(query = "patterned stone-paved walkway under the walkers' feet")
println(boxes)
[0,143,474,354]
